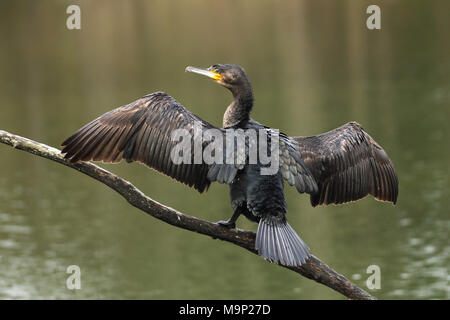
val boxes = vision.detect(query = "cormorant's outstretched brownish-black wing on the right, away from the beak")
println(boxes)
[292,122,398,206]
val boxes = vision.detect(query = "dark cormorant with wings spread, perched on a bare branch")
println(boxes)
[62,64,398,266]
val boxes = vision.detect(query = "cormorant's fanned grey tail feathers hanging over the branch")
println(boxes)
[255,217,311,266]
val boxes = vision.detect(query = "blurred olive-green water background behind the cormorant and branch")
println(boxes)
[0,0,450,299]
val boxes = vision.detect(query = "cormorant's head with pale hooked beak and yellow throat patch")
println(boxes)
[185,64,250,93]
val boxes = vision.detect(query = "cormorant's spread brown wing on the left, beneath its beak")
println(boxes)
[62,92,237,192]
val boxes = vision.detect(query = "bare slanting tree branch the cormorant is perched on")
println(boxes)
[0,130,376,300]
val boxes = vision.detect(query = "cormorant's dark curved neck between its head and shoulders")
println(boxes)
[223,84,253,128]
